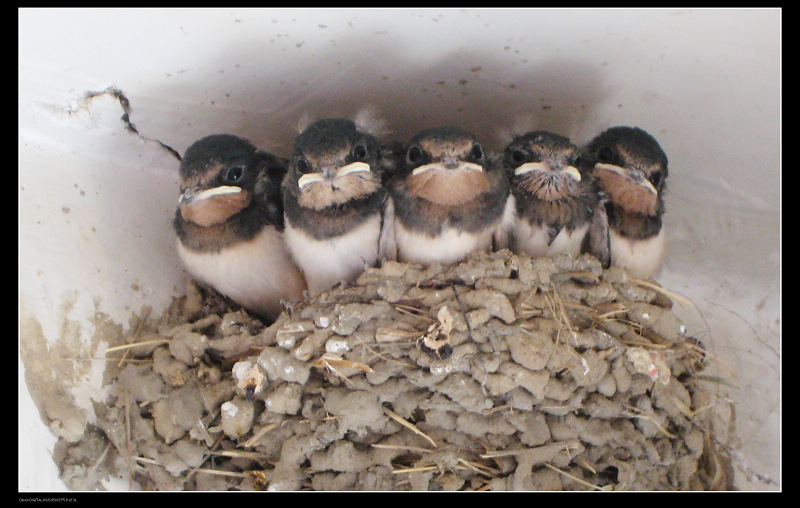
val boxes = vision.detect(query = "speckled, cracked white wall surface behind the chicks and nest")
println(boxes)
[19,9,781,490]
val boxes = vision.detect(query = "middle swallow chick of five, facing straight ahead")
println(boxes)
[389,127,514,265]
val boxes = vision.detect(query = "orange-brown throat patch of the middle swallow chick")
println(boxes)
[406,169,489,206]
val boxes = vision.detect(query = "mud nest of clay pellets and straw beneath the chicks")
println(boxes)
[55,251,733,490]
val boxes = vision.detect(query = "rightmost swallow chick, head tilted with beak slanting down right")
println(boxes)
[586,127,668,278]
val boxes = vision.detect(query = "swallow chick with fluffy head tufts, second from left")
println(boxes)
[283,112,388,295]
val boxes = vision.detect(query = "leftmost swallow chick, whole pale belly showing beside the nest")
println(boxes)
[173,134,305,321]
